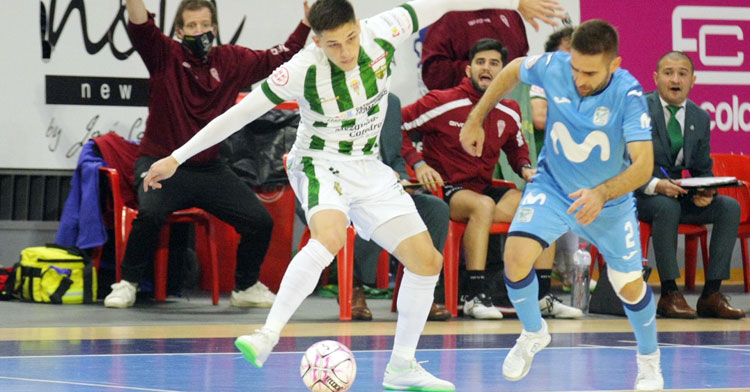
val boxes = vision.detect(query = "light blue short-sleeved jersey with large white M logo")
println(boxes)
[521,51,651,204]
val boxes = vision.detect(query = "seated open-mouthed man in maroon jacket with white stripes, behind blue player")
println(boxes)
[401,38,583,319]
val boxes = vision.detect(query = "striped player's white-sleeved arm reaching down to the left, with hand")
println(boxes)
[143,88,276,192]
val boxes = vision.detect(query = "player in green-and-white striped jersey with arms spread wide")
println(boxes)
[145,0,562,391]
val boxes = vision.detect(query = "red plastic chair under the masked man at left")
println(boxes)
[101,167,219,305]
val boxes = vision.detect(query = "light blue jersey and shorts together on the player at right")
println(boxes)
[509,52,651,272]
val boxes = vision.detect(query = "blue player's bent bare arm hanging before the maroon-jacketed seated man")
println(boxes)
[458,57,525,157]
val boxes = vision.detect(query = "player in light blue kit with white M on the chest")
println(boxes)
[461,20,664,390]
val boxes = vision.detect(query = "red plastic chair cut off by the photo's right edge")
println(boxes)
[711,154,750,293]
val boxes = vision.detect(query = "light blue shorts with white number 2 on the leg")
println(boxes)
[508,174,642,272]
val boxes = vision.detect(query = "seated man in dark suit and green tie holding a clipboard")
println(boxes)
[636,52,745,319]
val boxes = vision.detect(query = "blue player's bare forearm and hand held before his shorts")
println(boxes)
[568,140,654,225]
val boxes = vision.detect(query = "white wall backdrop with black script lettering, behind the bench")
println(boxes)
[0,0,580,169]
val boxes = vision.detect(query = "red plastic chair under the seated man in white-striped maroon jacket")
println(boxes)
[391,179,516,317]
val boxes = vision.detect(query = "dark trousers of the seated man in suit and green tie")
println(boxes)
[637,195,740,281]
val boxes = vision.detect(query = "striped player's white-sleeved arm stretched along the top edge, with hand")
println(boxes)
[408,0,566,30]
